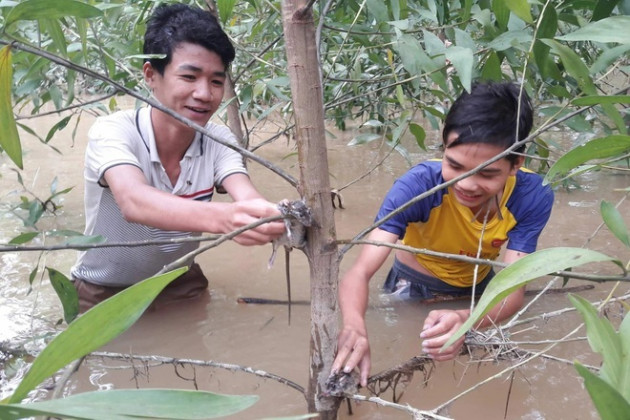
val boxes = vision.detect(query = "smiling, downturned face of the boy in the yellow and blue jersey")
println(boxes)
[442,133,523,213]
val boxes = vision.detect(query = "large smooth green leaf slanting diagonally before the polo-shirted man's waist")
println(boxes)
[8,268,187,403]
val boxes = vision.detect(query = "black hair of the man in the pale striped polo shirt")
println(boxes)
[143,3,235,75]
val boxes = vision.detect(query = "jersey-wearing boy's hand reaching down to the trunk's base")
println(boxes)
[331,326,371,387]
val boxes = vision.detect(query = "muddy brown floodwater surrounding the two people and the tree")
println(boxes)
[0,106,630,419]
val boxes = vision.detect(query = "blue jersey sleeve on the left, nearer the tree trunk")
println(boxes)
[375,162,444,239]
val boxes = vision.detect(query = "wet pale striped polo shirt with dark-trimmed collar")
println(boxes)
[72,107,247,287]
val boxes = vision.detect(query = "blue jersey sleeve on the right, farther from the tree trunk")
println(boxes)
[507,173,554,254]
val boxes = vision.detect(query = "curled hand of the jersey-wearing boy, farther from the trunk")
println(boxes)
[420,309,468,361]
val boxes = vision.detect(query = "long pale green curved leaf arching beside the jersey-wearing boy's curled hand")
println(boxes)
[442,247,622,348]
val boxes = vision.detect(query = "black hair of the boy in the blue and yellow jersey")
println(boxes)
[442,82,534,163]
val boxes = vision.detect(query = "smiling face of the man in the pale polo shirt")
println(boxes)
[143,42,226,126]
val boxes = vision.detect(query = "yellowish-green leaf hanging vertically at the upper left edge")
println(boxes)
[0,45,24,169]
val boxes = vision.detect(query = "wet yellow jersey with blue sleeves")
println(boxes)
[376,160,553,287]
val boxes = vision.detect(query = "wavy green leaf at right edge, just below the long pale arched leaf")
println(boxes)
[569,294,630,391]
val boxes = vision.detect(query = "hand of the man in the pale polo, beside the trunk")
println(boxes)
[222,198,285,245]
